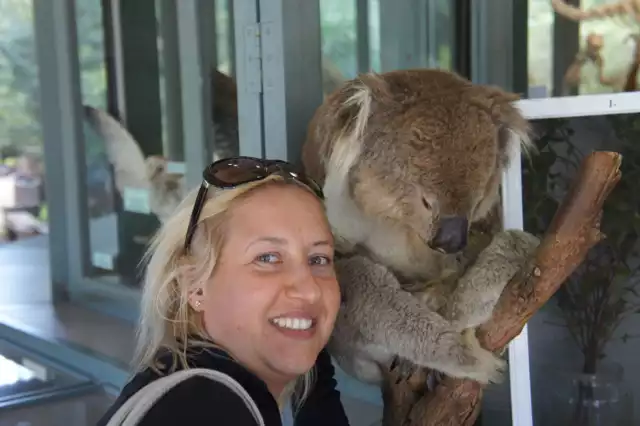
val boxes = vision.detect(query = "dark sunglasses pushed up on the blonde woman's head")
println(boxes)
[184,156,324,250]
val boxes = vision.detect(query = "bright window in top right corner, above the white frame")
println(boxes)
[528,0,640,97]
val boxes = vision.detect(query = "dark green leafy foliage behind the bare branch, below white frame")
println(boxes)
[523,115,640,373]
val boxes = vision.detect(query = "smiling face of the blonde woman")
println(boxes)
[202,185,340,393]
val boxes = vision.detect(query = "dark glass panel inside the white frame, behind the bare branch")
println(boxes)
[523,114,640,426]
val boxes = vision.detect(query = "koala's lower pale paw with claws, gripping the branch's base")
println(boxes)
[461,329,507,384]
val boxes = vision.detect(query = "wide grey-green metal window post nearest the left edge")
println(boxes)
[33,0,89,302]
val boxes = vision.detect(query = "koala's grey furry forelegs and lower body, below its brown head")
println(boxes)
[329,230,538,384]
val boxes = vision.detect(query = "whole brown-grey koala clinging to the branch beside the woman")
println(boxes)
[302,69,538,384]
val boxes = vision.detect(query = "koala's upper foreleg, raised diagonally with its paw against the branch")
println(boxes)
[441,229,540,330]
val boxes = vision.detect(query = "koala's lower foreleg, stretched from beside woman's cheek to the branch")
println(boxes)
[336,256,505,383]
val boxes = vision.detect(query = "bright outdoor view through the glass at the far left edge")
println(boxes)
[0,0,47,244]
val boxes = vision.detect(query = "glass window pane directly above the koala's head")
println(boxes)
[320,0,453,87]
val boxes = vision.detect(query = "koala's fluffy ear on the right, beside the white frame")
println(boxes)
[468,85,535,165]
